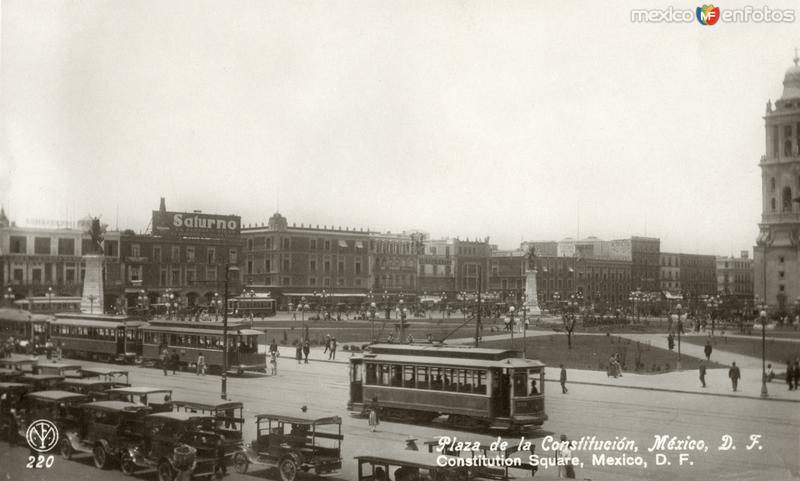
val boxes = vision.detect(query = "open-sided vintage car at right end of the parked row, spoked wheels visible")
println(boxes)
[233,414,344,481]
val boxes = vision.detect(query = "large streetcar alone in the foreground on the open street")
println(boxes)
[347,344,547,431]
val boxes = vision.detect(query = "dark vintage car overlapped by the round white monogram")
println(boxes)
[13,391,86,447]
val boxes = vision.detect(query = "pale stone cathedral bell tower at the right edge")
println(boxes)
[753,49,800,310]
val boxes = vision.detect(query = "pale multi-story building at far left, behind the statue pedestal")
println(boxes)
[0,210,120,309]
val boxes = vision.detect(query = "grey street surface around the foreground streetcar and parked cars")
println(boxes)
[0,353,800,481]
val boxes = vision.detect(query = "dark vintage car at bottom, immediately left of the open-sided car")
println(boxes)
[120,412,224,481]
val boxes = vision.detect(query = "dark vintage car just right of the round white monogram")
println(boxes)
[60,401,150,469]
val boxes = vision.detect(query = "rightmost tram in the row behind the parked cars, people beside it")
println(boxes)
[139,320,267,375]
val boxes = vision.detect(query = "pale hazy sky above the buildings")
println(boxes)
[0,0,800,255]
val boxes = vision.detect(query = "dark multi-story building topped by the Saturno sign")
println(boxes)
[114,198,244,307]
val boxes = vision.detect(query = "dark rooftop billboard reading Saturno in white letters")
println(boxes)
[153,210,242,238]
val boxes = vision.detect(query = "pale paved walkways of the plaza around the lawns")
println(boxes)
[280,330,800,402]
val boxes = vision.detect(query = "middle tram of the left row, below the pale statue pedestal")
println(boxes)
[50,313,145,362]
